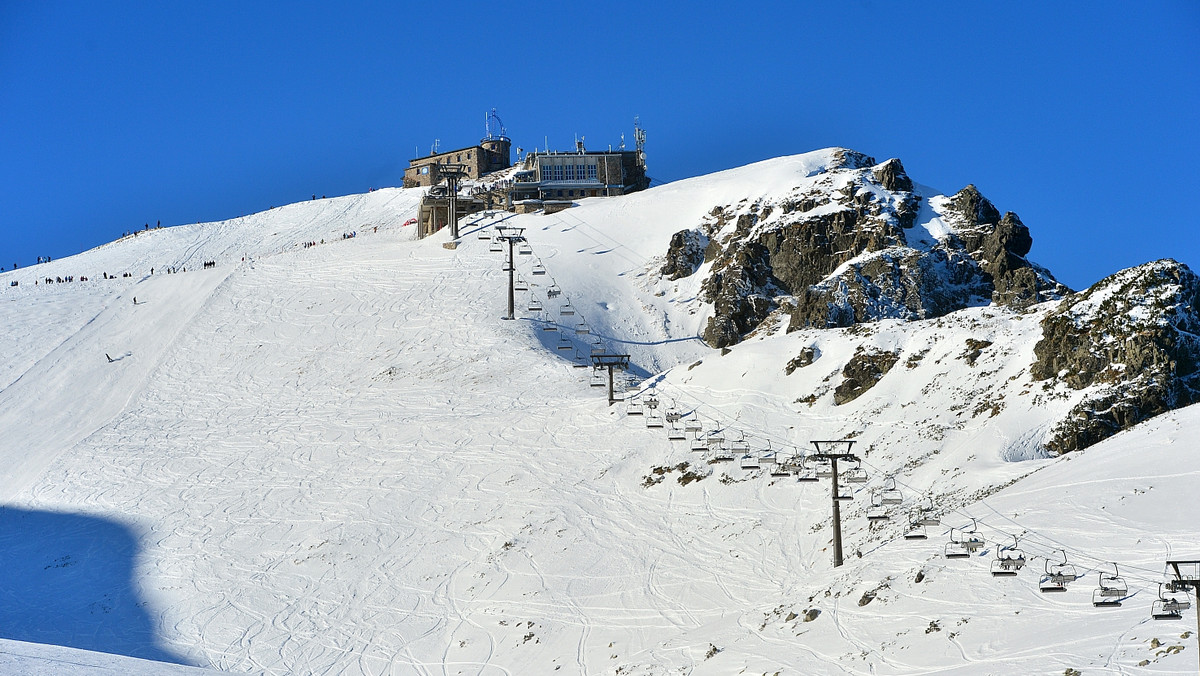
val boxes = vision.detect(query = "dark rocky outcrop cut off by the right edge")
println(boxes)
[1031,259,1200,454]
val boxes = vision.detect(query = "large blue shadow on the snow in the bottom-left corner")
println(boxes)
[0,505,188,664]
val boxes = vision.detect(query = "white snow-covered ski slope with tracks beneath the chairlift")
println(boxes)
[0,151,1200,676]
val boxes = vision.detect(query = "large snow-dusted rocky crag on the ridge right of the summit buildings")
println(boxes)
[662,149,1069,347]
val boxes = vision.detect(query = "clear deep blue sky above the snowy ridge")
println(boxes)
[0,0,1200,288]
